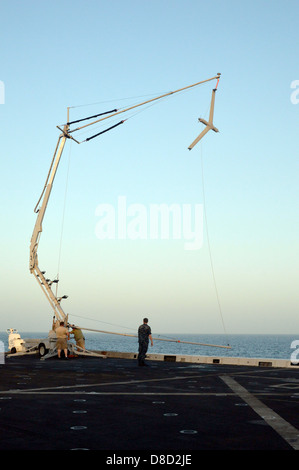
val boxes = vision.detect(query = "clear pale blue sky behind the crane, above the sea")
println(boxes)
[0,0,299,334]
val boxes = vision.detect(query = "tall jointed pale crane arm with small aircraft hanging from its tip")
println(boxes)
[24,73,231,360]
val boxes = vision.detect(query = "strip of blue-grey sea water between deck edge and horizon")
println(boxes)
[0,331,299,360]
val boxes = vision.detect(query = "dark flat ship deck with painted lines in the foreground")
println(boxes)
[0,355,299,455]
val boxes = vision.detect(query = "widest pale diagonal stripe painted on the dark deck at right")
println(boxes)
[220,375,299,450]
